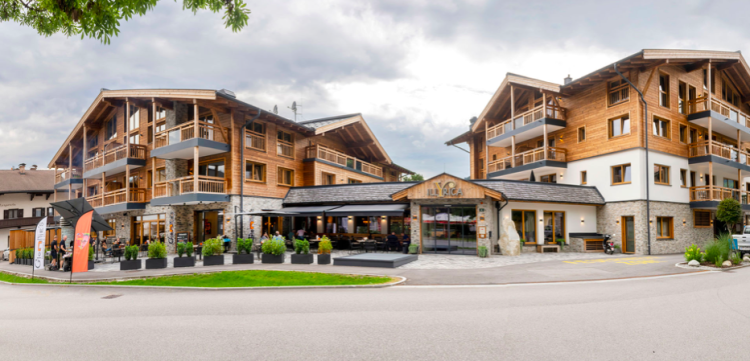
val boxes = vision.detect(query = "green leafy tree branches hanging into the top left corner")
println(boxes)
[0,0,250,44]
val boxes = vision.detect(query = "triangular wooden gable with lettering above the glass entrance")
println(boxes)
[391,173,503,201]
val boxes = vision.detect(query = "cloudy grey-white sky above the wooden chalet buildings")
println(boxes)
[0,0,750,176]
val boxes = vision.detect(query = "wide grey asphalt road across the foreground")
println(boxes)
[0,268,750,361]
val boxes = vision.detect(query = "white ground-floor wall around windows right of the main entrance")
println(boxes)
[500,202,596,244]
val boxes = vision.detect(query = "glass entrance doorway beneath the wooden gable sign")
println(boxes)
[422,206,477,255]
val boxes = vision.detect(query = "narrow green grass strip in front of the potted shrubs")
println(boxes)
[86,271,391,287]
